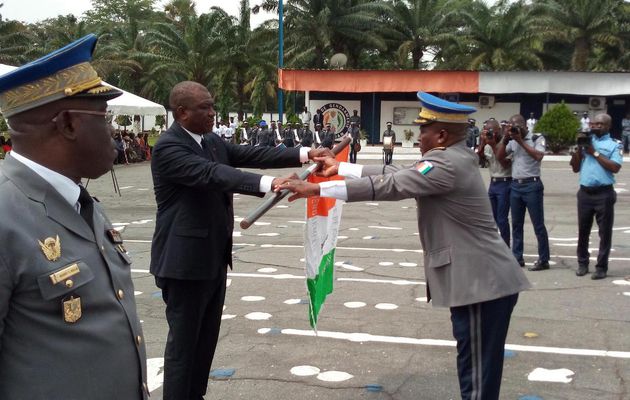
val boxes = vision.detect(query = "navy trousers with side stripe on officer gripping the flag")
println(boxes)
[451,293,518,400]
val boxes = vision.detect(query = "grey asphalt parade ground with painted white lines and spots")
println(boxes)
[71,148,630,400]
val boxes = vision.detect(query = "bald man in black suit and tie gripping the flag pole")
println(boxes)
[151,82,332,400]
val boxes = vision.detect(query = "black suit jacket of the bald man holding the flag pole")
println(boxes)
[151,123,301,279]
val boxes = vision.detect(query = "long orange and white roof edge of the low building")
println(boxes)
[278,69,630,96]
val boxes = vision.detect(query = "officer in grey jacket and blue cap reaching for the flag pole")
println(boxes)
[276,92,530,400]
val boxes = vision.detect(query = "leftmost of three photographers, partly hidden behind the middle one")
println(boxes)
[477,119,512,247]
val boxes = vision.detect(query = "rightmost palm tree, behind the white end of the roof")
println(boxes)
[534,0,624,71]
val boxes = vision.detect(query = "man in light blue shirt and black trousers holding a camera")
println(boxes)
[571,114,623,279]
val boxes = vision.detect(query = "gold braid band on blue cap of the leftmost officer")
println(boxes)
[0,62,101,117]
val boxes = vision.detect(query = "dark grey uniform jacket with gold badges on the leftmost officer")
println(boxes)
[0,156,147,400]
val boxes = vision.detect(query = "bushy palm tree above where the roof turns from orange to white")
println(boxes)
[439,0,544,71]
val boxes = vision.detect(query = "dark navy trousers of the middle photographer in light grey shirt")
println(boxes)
[510,178,549,263]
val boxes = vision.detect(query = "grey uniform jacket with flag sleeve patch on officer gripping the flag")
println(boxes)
[346,141,530,307]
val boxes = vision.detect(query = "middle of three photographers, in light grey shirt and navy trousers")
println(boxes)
[497,114,549,271]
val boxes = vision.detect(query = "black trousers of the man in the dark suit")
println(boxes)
[155,275,226,400]
